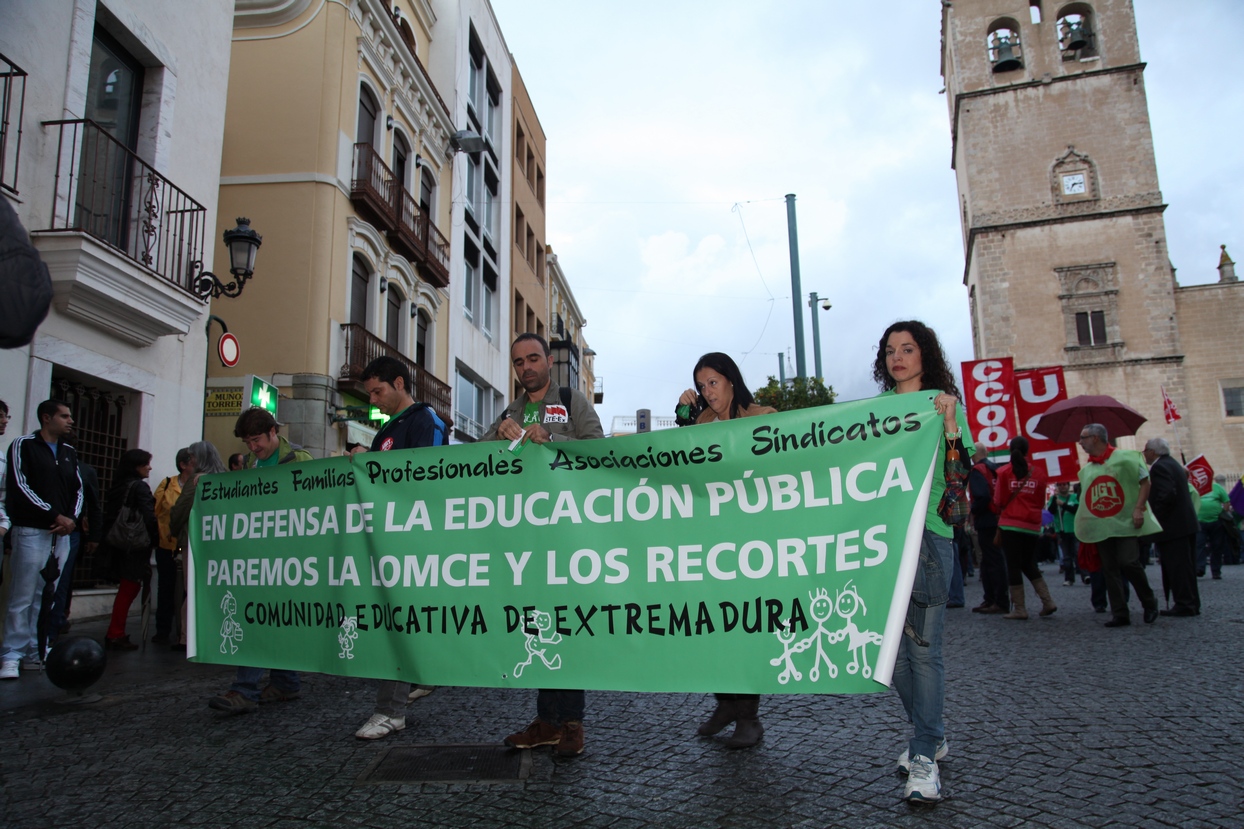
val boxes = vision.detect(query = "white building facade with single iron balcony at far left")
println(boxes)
[0,0,234,575]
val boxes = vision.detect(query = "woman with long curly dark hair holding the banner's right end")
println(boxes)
[872,320,974,802]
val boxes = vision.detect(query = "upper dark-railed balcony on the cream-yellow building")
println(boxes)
[350,144,449,288]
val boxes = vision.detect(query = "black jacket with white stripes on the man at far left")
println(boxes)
[5,432,82,529]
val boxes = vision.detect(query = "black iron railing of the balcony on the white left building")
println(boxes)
[44,118,208,294]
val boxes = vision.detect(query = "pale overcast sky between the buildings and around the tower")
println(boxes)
[493,0,1244,431]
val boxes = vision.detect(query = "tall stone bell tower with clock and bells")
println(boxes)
[942,0,1183,438]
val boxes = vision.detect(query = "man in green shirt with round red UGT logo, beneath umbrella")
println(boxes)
[1076,423,1162,627]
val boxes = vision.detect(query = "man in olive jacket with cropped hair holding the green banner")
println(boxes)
[481,334,605,757]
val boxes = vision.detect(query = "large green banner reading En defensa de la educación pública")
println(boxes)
[189,393,942,693]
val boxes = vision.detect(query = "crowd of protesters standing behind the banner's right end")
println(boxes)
[962,423,1240,627]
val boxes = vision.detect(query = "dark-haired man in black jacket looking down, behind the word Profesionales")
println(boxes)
[355,357,449,739]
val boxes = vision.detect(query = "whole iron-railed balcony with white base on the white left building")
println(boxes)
[32,118,208,345]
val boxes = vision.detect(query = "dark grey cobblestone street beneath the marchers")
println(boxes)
[0,565,1244,829]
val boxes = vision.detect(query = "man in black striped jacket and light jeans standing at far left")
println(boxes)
[0,400,82,680]
